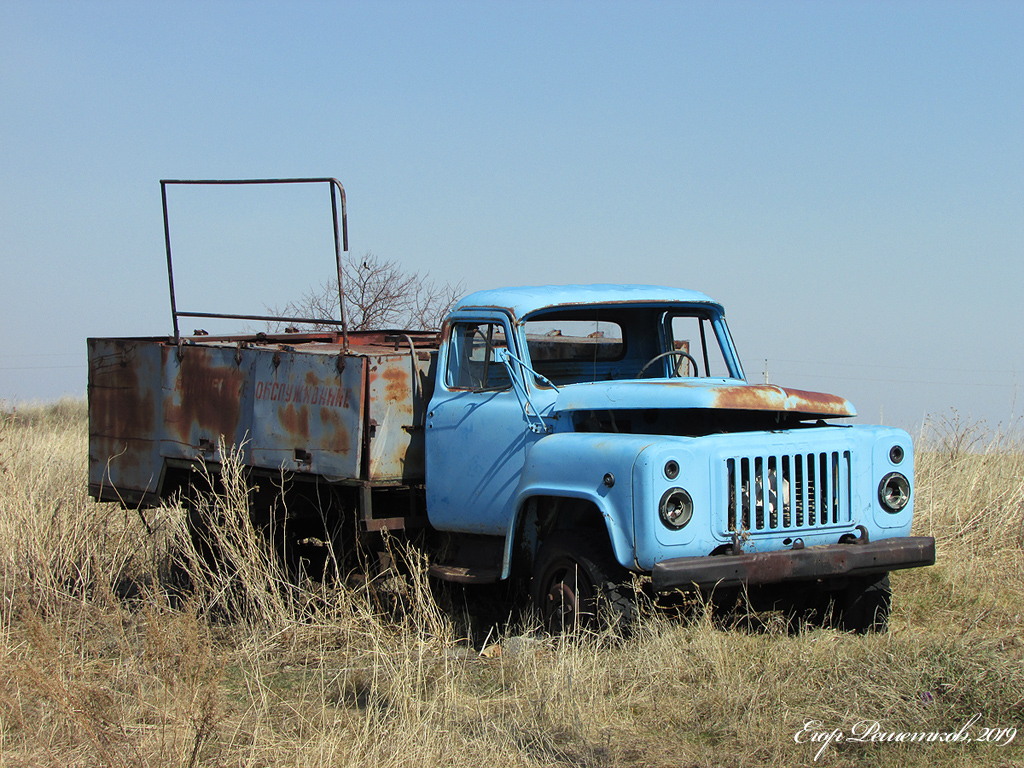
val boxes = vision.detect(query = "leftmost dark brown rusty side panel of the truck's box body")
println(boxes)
[88,339,163,503]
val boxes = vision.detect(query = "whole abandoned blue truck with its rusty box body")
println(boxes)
[88,179,935,631]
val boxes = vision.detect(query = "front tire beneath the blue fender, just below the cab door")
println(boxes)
[530,531,636,634]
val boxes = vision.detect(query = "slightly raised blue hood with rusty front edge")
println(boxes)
[555,379,857,418]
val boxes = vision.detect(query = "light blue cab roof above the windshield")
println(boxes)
[454,284,724,318]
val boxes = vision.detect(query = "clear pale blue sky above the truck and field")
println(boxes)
[0,0,1024,434]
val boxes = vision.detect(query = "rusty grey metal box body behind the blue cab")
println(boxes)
[89,338,436,504]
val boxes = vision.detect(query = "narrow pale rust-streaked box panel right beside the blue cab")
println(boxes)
[367,352,436,483]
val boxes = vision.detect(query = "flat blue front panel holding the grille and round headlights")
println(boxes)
[633,426,913,569]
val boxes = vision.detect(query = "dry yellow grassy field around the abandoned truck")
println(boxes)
[0,401,1024,768]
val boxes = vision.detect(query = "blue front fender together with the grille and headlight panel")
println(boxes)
[505,427,912,570]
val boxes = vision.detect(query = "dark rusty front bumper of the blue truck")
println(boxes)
[651,537,935,592]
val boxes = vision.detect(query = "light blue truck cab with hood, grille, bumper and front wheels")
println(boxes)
[425,285,934,629]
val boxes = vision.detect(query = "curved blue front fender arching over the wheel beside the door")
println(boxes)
[502,432,652,579]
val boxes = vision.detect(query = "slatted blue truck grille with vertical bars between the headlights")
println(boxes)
[725,451,851,532]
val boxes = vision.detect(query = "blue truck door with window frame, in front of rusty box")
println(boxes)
[426,312,539,536]
